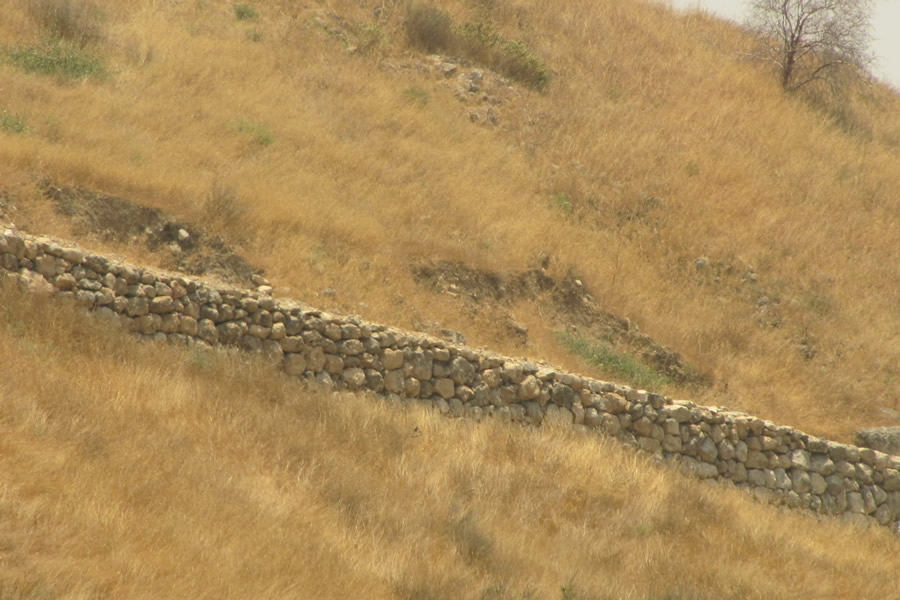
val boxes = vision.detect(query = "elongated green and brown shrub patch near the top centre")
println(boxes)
[406,3,552,90]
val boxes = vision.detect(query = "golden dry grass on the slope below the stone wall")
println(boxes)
[0,287,900,600]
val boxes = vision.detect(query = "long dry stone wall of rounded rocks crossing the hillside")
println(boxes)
[0,228,900,533]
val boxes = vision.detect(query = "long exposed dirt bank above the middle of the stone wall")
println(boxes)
[412,261,710,385]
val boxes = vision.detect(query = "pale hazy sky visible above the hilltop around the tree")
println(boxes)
[663,0,900,90]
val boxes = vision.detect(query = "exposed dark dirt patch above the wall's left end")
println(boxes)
[41,182,261,287]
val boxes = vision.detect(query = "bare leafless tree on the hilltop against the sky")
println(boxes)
[750,0,872,91]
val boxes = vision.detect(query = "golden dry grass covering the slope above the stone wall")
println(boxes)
[0,0,900,440]
